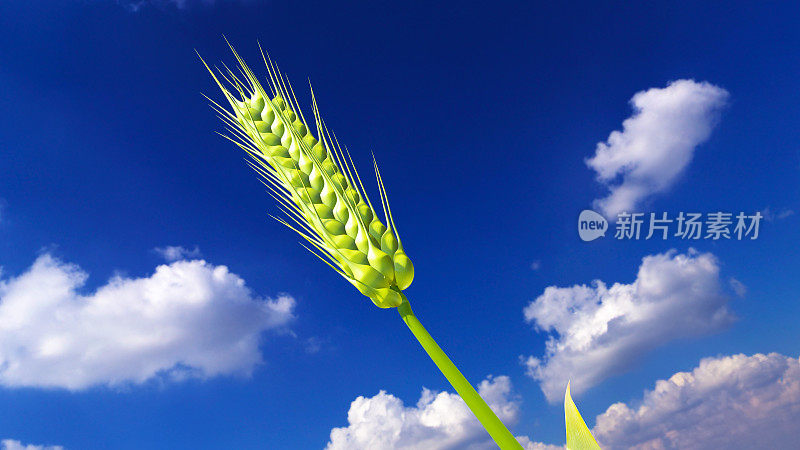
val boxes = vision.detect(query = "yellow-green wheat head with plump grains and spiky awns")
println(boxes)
[204,44,414,308]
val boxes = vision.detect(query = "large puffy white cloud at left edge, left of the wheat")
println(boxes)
[0,254,295,390]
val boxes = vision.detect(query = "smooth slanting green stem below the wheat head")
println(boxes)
[397,294,522,450]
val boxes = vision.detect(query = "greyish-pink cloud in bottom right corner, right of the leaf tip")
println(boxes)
[593,353,800,450]
